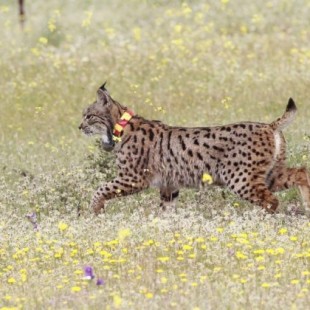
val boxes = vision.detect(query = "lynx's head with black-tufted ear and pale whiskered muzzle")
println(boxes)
[79,83,115,151]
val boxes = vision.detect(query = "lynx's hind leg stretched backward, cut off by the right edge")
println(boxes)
[267,166,310,212]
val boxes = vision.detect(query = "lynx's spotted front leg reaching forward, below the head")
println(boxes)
[91,177,148,215]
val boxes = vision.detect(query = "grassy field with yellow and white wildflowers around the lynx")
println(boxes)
[0,0,310,310]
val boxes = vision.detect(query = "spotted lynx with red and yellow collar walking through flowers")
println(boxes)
[79,84,310,214]
